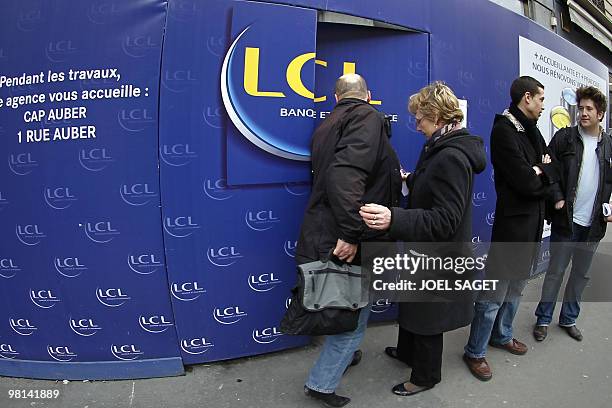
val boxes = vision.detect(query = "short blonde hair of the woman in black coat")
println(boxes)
[408,81,463,124]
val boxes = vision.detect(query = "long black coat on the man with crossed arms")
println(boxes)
[487,105,558,279]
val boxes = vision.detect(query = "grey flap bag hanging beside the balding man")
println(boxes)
[298,256,370,312]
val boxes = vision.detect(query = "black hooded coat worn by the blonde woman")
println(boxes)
[389,129,487,335]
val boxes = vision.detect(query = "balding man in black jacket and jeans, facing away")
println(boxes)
[296,74,401,407]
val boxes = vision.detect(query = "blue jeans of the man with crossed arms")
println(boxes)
[464,280,527,358]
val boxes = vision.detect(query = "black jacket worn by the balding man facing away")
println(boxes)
[296,98,401,263]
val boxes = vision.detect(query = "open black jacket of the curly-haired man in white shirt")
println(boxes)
[548,126,612,241]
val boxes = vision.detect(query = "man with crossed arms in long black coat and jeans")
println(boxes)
[463,76,557,381]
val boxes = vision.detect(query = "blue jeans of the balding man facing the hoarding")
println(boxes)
[306,304,370,394]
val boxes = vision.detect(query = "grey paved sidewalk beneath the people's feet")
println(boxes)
[0,234,612,408]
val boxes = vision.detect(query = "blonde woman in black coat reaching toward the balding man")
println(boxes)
[360,82,486,396]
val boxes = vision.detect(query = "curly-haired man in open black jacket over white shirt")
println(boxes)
[533,86,612,341]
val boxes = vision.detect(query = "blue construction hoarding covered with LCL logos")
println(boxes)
[0,0,607,379]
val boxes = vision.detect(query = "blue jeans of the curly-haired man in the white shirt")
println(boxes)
[535,223,599,326]
